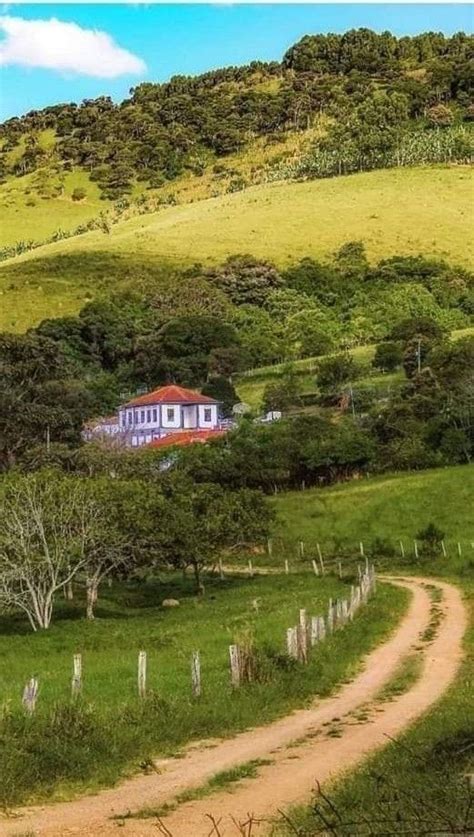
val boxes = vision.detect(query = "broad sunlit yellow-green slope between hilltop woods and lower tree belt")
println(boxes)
[0,167,473,330]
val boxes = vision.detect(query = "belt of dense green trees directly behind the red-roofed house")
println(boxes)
[0,242,474,467]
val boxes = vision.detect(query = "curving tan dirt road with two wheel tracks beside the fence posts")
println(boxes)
[0,578,467,837]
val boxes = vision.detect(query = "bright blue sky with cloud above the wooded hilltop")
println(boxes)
[0,2,473,121]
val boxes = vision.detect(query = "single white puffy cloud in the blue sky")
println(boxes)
[0,15,146,78]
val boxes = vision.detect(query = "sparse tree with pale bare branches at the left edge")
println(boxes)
[0,472,99,631]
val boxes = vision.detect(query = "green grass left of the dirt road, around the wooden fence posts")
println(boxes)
[0,573,407,807]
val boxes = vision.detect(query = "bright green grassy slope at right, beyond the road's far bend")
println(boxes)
[274,465,474,559]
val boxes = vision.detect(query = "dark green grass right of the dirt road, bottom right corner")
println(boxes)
[274,579,474,837]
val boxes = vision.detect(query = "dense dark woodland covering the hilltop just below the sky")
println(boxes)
[0,29,474,200]
